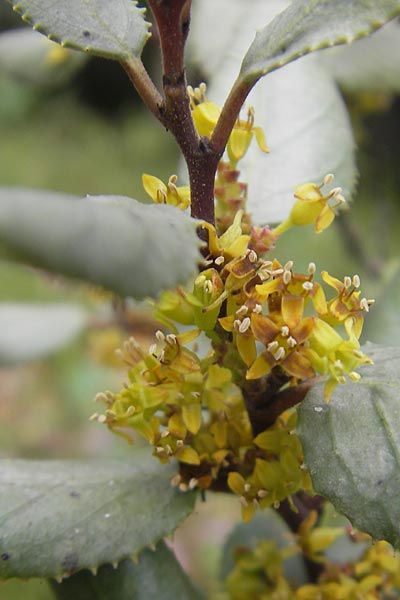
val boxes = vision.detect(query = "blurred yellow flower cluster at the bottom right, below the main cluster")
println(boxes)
[226,527,400,600]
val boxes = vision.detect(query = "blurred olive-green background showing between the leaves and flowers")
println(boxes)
[0,2,400,600]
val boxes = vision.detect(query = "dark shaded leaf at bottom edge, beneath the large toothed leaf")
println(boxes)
[52,542,202,600]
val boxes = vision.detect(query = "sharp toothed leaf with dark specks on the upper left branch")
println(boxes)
[9,0,149,60]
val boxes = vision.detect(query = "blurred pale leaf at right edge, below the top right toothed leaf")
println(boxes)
[321,21,400,93]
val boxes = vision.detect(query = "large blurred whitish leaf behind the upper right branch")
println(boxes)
[192,0,356,223]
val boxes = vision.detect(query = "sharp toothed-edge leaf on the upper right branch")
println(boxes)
[239,0,400,83]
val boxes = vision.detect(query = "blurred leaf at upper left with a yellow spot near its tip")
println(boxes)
[0,29,85,86]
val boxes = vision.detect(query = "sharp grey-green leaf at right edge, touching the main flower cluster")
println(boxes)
[298,344,400,548]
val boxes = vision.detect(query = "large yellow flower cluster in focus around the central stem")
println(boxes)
[94,86,373,520]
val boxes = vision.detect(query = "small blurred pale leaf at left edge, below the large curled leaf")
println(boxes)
[0,302,87,366]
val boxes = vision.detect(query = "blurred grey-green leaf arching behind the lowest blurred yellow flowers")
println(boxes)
[221,509,308,585]
